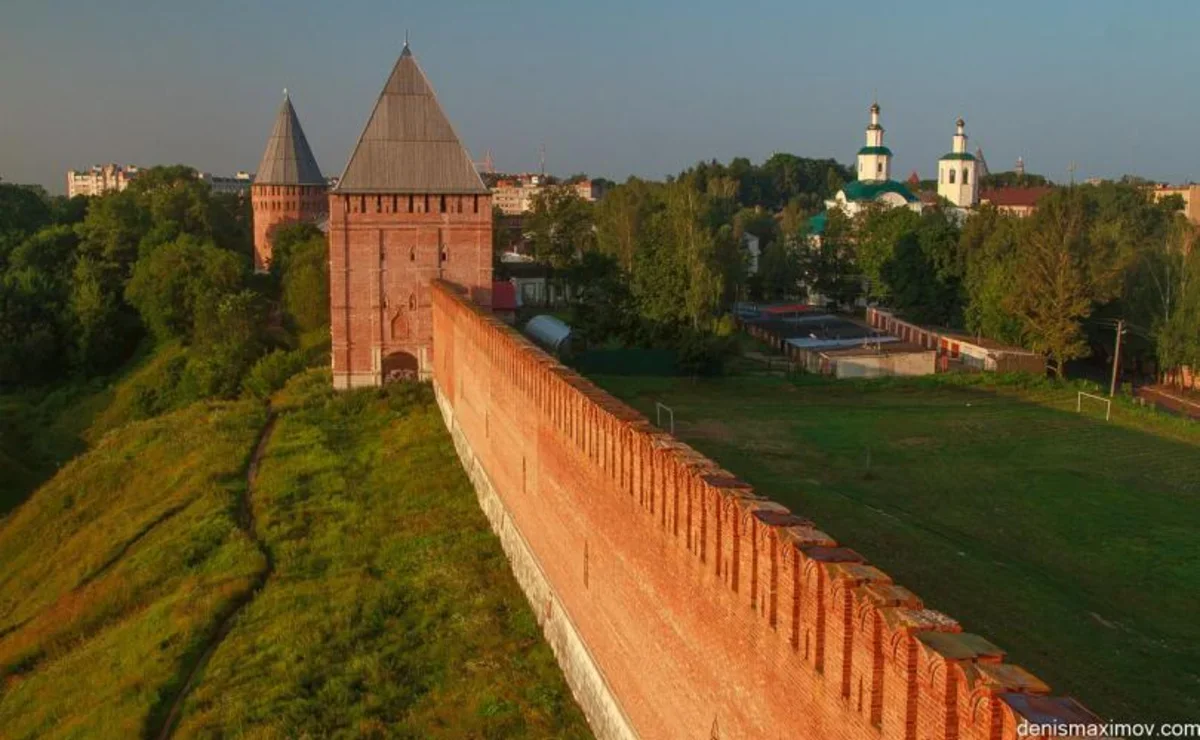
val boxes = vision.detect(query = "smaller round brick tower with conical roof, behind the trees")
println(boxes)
[250,90,329,272]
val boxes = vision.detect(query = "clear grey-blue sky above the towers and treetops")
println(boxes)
[0,0,1200,192]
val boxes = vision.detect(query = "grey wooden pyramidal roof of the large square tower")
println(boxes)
[336,42,488,193]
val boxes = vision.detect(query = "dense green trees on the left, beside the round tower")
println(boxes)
[0,167,329,400]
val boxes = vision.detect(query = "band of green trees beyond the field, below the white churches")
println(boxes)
[526,155,1200,377]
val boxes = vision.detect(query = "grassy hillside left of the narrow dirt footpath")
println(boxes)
[0,403,265,738]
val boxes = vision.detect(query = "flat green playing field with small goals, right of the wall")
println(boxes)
[594,374,1200,721]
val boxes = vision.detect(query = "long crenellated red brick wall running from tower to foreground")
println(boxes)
[431,281,1094,740]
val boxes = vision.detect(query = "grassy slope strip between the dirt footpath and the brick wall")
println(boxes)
[176,372,590,738]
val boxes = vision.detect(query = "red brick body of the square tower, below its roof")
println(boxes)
[329,192,492,389]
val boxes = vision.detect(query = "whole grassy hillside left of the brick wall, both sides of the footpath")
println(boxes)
[0,371,590,739]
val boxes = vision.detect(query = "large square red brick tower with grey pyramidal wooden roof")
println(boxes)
[329,43,492,389]
